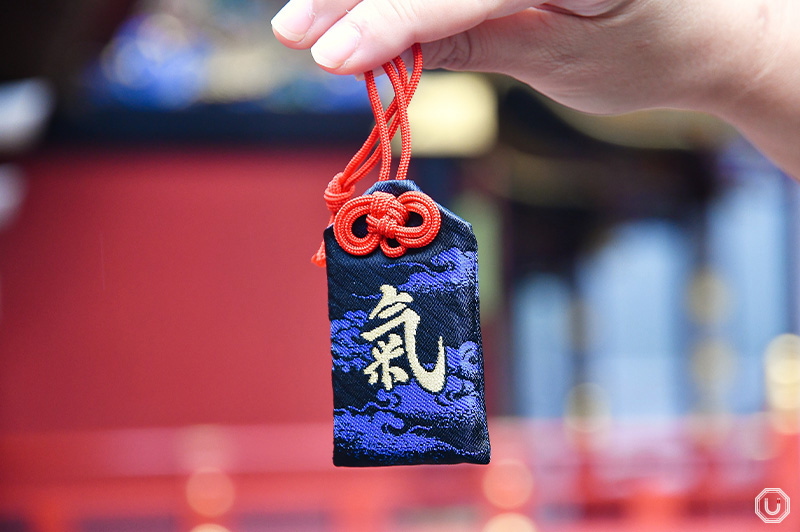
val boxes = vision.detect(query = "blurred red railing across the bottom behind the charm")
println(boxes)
[0,420,800,532]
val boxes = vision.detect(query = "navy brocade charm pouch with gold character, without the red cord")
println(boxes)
[325,180,490,466]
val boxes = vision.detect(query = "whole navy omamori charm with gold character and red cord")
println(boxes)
[312,45,489,466]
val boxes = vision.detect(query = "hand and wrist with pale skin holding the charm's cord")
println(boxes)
[272,0,800,178]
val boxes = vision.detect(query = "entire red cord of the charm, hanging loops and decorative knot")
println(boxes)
[311,44,441,266]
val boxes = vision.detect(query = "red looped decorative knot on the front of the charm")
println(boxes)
[333,191,442,258]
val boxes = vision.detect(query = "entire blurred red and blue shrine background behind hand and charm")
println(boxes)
[0,0,800,532]
